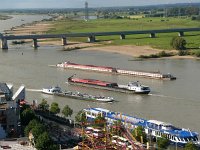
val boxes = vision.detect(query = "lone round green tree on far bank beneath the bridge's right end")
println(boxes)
[170,37,186,50]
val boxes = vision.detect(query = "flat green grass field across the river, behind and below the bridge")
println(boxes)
[48,18,200,49]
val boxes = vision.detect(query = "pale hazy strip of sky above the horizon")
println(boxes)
[0,0,200,9]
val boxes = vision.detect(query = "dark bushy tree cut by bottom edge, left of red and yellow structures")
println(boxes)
[35,132,59,150]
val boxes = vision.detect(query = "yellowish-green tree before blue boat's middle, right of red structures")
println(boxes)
[132,126,147,143]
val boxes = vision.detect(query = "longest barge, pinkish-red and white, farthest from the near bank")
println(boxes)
[56,61,176,80]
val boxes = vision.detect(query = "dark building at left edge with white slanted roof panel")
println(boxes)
[0,83,25,139]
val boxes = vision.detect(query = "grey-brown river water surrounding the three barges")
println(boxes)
[0,16,200,133]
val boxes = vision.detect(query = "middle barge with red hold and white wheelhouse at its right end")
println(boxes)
[68,76,150,94]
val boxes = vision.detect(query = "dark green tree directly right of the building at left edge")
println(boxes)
[21,108,36,126]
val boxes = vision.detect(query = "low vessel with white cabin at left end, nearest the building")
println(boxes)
[42,86,114,102]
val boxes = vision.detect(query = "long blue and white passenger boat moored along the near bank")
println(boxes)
[84,108,200,146]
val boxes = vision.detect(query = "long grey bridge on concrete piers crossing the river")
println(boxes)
[0,28,200,49]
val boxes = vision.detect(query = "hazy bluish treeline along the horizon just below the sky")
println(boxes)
[0,3,200,15]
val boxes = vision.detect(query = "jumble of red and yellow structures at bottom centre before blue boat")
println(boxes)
[74,122,149,150]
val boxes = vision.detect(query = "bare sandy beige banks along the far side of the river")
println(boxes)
[5,16,198,59]
